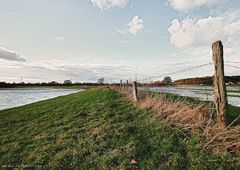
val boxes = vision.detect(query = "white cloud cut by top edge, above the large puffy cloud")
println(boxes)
[167,0,229,12]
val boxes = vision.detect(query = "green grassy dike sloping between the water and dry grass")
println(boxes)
[0,88,240,169]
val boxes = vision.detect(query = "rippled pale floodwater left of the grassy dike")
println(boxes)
[0,88,82,110]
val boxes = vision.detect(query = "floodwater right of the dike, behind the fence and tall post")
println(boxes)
[149,86,240,107]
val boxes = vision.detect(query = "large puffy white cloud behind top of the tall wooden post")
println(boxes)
[168,12,240,51]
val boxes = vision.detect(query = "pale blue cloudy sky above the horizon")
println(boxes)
[0,0,240,82]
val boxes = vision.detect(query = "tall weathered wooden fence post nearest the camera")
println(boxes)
[212,41,228,128]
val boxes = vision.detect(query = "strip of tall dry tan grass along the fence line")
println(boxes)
[114,87,240,154]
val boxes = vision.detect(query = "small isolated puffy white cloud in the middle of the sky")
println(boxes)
[127,16,144,35]
